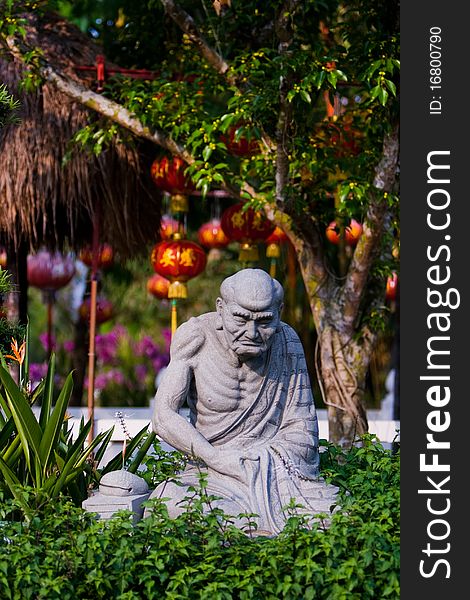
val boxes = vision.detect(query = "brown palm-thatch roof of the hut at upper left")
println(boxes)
[0,14,160,256]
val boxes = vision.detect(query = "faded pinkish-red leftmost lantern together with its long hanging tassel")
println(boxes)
[27,250,75,355]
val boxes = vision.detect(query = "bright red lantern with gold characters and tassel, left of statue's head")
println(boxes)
[150,233,207,334]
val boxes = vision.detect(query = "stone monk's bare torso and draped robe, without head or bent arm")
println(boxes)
[152,313,337,533]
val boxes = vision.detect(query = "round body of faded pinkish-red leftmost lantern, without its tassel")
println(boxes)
[27,250,75,292]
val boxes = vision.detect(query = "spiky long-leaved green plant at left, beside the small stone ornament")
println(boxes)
[0,341,151,520]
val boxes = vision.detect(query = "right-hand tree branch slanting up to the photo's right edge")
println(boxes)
[342,126,399,332]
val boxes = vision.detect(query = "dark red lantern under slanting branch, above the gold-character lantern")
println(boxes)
[150,156,195,213]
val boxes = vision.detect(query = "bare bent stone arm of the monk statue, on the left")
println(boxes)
[152,321,219,463]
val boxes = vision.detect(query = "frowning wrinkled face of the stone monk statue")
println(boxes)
[217,298,280,360]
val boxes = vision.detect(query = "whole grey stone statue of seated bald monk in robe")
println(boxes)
[146,269,338,534]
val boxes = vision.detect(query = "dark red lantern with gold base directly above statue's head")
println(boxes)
[221,202,276,262]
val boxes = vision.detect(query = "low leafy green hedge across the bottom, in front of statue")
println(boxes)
[0,436,399,600]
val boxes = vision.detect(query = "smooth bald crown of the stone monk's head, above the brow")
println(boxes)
[220,269,284,311]
